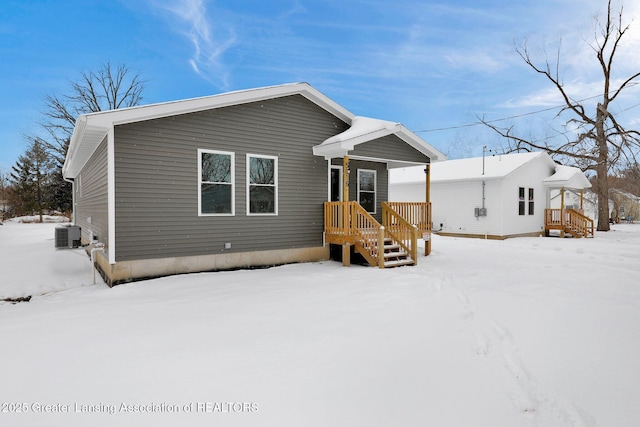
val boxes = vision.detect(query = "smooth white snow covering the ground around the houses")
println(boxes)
[0,222,640,427]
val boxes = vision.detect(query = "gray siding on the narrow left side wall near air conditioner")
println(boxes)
[74,138,109,245]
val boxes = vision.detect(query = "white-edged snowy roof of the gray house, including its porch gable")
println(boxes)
[62,83,444,178]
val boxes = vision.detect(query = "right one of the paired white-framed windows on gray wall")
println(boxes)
[247,154,278,215]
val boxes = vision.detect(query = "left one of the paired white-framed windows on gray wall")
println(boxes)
[198,150,235,215]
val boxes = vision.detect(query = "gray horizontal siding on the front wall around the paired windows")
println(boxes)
[114,95,347,261]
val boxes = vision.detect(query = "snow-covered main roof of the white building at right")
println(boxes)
[390,152,555,184]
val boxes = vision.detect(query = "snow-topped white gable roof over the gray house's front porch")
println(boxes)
[313,116,446,166]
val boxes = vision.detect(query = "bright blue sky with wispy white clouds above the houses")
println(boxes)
[0,0,640,171]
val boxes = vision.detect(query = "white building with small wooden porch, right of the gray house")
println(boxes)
[389,152,591,239]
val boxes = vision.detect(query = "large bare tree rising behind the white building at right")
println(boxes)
[482,0,640,231]
